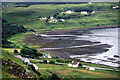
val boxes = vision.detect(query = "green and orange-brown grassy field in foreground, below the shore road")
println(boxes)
[30,62,118,78]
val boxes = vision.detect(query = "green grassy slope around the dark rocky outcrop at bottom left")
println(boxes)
[2,51,39,78]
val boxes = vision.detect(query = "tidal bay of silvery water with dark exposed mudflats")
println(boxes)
[33,28,120,67]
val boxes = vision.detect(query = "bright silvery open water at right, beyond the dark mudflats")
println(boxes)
[71,28,119,67]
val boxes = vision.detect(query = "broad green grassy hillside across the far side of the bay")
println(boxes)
[3,3,118,32]
